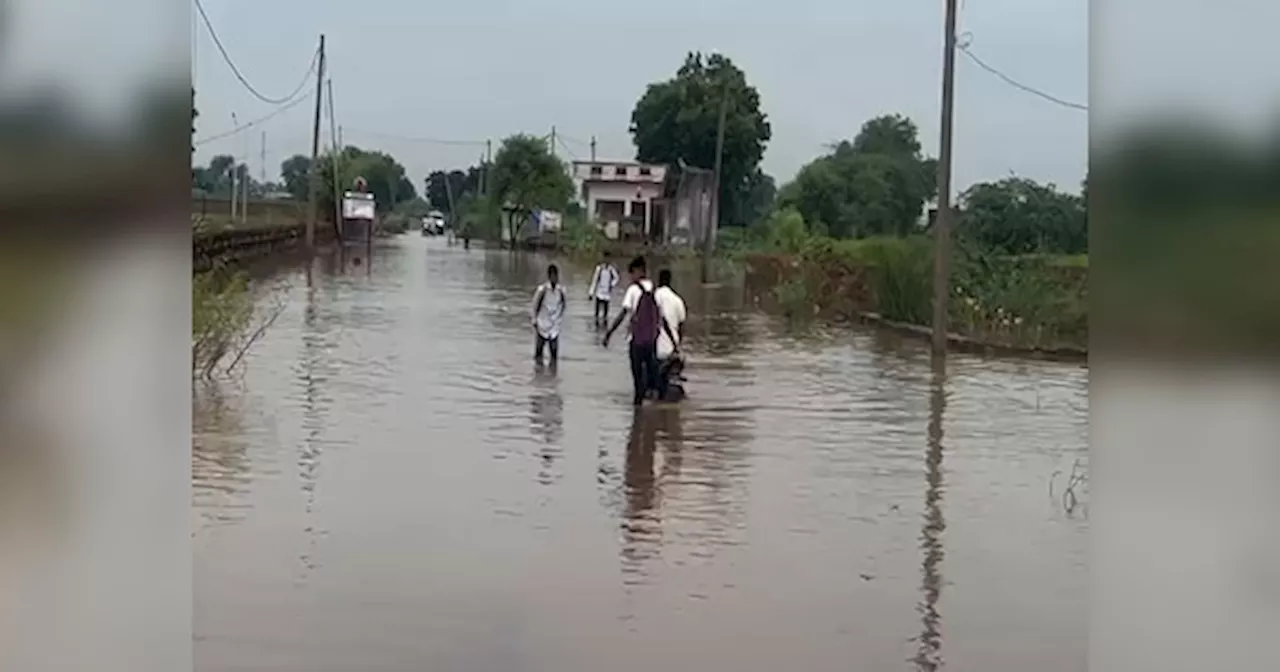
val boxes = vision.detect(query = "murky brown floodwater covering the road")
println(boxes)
[192,236,1088,672]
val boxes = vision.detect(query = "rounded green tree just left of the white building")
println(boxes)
[489,134,573,239]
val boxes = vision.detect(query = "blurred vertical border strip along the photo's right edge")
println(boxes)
[1088,0,1280,672]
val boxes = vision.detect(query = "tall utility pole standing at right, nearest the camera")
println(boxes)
[933,0,957,357]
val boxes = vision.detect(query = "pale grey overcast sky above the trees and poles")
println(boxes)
[180,0,1088,188]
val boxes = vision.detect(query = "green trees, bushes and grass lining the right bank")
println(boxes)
[718,108,1088,348]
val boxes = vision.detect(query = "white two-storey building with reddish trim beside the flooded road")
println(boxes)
[573,161,667,239]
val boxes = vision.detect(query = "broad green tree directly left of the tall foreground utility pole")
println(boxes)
[778,114,937,238]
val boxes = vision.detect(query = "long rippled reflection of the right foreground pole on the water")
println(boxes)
[913,356,947,672]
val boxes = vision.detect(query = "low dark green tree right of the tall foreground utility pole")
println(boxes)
[957,178,1089,255]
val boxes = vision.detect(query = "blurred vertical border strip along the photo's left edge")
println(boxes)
[0,0,192,672]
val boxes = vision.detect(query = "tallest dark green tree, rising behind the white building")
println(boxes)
[631,52,773,225]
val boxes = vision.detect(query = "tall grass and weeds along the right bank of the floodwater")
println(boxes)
[724,210,1088,348]
